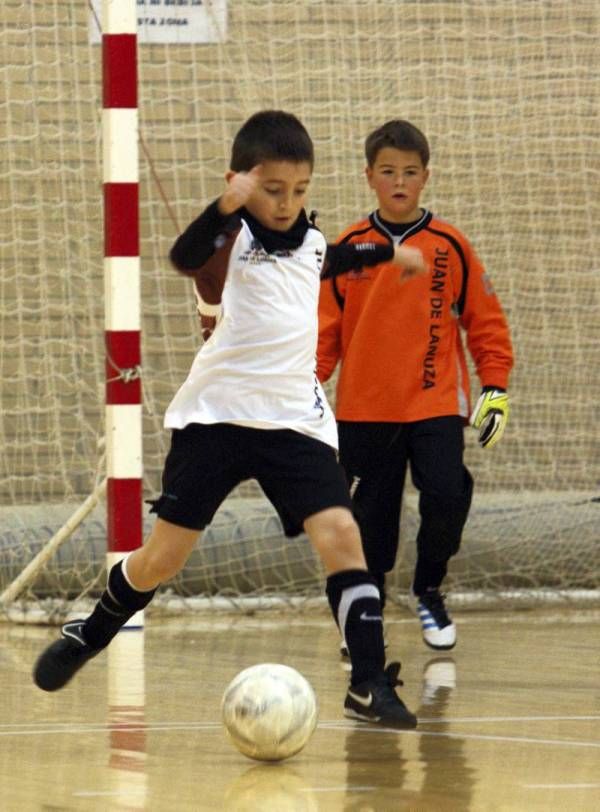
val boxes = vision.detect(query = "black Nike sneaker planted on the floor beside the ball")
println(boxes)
[344,663,417,730]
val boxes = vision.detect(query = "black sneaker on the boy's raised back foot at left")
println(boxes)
[33,620,102,691]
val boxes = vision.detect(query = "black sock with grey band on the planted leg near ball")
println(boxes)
[327,570,385,685]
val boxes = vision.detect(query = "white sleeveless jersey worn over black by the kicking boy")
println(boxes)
[165,220,337,448]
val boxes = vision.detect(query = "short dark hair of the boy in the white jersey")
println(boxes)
[231,110,314,172]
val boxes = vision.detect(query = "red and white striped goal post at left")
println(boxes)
[102,0,142,625]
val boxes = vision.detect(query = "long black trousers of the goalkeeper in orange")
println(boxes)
[338,415,473,594]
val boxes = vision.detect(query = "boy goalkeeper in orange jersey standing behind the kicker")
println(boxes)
[317,120,513,651]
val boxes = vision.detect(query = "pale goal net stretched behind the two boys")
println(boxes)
[0,0,600,617]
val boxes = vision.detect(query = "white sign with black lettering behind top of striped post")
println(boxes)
[90,0,227,43]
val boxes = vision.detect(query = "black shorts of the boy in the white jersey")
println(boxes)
[151,423,352,536]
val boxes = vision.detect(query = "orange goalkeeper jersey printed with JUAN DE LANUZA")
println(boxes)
[317,211,513,423]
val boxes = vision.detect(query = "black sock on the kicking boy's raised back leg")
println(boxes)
[83,561,156,648]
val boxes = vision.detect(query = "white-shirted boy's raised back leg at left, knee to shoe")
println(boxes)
[33,519,199,691]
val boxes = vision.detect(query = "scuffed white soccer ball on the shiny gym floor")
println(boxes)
[221,663,317,761]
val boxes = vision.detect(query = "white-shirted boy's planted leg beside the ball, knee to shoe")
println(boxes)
[304,507,417,729]
